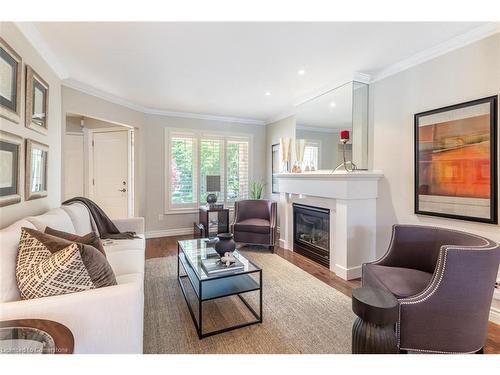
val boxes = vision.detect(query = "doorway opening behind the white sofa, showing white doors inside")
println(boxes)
[62,114,135,219]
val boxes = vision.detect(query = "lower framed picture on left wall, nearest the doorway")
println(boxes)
[24,139,49,200]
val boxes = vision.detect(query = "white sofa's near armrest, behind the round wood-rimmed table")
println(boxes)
[0,274,144,354]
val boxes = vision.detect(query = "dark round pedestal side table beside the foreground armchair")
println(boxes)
[352,287,399,354]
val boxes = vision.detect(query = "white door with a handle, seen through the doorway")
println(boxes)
[90,130,129,219]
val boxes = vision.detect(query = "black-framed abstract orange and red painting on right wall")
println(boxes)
[415,96,498,224]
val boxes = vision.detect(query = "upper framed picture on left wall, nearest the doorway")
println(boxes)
[25,66,49,134]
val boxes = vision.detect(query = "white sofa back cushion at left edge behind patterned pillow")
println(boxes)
[0,220,35,302]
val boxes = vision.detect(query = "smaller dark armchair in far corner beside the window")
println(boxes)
[231,199,276,251]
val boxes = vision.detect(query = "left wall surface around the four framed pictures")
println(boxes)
[0,22,61,228]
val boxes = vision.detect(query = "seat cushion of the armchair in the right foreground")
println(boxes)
[363,264,432,298]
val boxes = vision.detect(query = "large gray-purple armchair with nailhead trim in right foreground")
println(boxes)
[363,225,500,353]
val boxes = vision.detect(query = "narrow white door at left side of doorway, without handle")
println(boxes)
[64,134,84,200]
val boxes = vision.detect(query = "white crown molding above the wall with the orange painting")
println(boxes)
[370,22,500,83]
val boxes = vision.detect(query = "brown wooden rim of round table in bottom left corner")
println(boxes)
[0,319,75,354]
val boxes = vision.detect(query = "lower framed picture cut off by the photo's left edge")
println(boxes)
[0,130,23,207]
